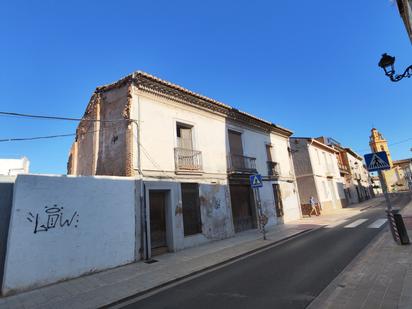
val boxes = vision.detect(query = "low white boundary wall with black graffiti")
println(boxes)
[3,175,140,294]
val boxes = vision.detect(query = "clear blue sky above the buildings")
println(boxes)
[0,0,412,174]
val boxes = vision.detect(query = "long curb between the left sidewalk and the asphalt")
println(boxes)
[99,225,324,308]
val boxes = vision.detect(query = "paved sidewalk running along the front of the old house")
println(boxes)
[0,198,374,309]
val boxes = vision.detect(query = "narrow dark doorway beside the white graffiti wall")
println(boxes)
[149,190,168,255]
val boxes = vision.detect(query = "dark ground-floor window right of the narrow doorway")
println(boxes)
[181,183,202,236]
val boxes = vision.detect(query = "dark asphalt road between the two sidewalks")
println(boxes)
[117,194,409,309]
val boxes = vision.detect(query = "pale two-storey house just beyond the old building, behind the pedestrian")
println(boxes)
[290,137,346,214]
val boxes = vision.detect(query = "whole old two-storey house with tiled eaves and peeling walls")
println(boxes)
[68,72,301,252]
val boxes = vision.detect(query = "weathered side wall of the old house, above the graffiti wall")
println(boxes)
[67,84,135,176]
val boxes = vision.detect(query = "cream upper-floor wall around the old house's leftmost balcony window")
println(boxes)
[132,93,227,178]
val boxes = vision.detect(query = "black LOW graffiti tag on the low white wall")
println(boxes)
[26,204,79,234]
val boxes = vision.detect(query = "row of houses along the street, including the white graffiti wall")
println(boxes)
[0,72,392,295]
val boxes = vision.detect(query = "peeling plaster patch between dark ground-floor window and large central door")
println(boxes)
[199,184,234,240]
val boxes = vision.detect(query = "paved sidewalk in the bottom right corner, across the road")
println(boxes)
[308,191,412,309]
